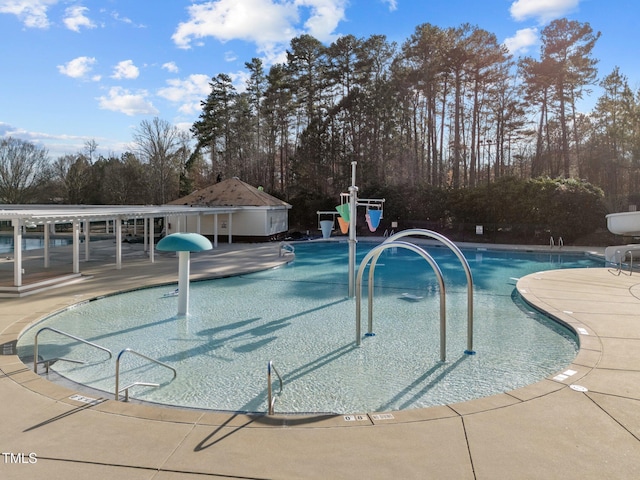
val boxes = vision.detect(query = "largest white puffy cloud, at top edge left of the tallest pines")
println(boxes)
[172,0,347,58]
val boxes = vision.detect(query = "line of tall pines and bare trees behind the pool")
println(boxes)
[0,19,640,238]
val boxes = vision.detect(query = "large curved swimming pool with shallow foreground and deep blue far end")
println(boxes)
[19,242,603,413]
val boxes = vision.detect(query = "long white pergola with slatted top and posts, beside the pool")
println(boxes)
[0,205,241,288]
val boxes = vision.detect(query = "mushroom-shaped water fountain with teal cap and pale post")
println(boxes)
[157,233,213,315]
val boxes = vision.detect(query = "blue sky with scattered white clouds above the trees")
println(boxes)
[0,0,640,158]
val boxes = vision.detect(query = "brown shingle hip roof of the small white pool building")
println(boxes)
[169,177,291,208]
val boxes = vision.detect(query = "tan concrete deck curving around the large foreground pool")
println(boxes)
[0,242,640,480]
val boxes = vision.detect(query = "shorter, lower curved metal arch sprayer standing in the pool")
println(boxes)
[356,241,447,362]
